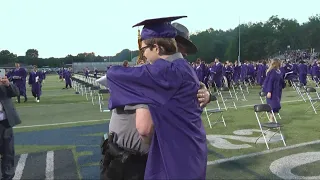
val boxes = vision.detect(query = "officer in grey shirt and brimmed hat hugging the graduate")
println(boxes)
[100,18,210,180]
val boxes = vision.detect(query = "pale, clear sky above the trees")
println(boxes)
[0,0,320,58]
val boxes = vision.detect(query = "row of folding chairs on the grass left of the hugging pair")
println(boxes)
[72,74,110,112]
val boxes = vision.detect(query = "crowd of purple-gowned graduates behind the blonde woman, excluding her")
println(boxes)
[192,58,320,88]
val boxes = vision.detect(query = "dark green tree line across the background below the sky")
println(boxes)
[0,15,320,67]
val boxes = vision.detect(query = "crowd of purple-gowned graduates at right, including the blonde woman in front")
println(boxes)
[192,58,320,121]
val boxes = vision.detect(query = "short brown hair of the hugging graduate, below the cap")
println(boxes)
[143,38,178,56]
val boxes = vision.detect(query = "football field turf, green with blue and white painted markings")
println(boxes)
[10,75,320,179]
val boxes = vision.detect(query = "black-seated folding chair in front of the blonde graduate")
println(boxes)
[253,104,287,149]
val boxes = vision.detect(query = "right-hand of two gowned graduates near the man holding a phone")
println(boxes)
[29,67,43,102]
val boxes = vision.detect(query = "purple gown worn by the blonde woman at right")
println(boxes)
[263,69,284,113]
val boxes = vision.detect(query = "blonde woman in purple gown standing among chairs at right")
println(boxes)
[263,59,285,122]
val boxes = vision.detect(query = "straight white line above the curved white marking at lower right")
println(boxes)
[207,140,320,165]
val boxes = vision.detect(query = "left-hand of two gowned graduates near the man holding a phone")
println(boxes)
[12,63,28,103]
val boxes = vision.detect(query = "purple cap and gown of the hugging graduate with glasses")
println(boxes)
[107,17,207,179]
